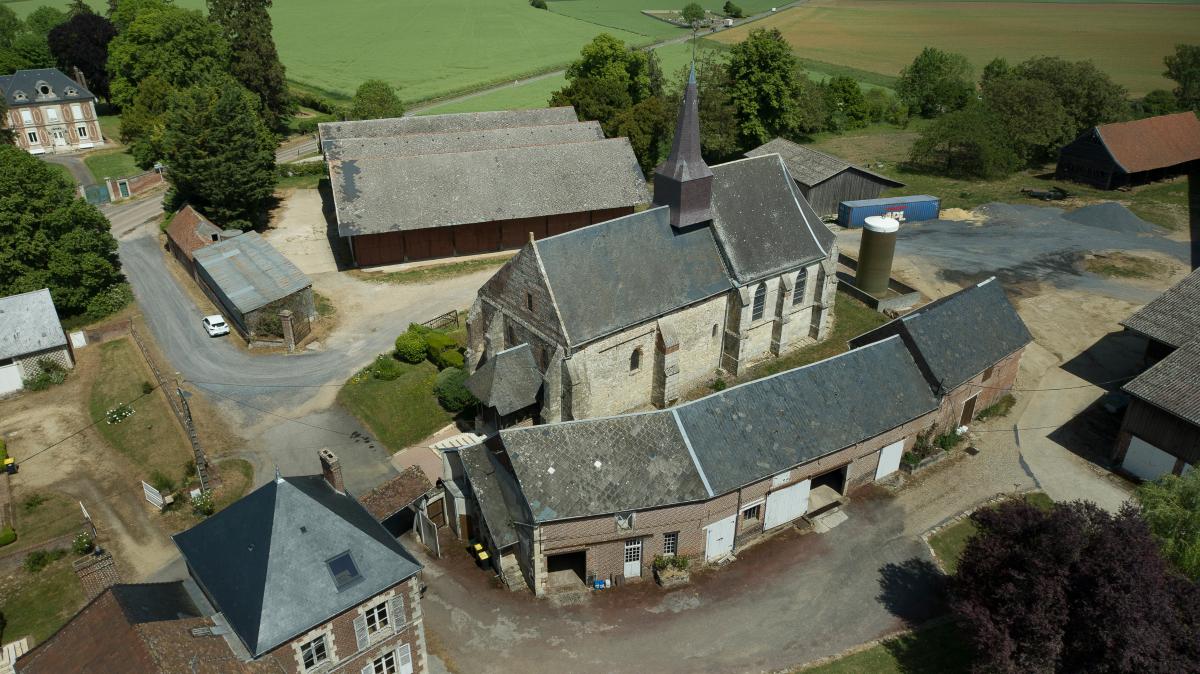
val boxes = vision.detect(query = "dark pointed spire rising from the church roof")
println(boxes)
[654,64,713,227]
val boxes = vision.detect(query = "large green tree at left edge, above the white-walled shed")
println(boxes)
[0,145,124,317]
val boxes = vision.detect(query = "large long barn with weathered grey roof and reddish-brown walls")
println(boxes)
[320,108,649,266]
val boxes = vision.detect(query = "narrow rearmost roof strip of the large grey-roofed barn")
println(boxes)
[317,106,580,142]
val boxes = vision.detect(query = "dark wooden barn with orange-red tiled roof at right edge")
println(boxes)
[1055,112,1200,189]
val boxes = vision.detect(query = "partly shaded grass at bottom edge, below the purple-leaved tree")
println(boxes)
[800,622,972,674]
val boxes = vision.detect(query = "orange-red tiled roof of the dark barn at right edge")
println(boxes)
[1096,112,1200,173]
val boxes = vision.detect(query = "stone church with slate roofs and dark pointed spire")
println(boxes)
[467,68,838,424]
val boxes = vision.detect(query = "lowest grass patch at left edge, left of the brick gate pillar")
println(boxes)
[0,555,84,644]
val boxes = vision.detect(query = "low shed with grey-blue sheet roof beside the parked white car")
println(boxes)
[194,231,317,342]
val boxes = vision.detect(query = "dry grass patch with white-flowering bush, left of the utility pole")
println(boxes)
[88,337,192,480]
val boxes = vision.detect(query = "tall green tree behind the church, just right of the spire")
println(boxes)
[728,29,800,148]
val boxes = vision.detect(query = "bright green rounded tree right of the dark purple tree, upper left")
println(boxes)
[108,5,229,108]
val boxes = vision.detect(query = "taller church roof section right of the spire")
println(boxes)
[713,155,834,285]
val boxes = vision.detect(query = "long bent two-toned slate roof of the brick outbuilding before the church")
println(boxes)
[500,337,937,522]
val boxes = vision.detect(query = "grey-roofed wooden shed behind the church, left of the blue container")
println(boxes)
[746,138,904,217]
